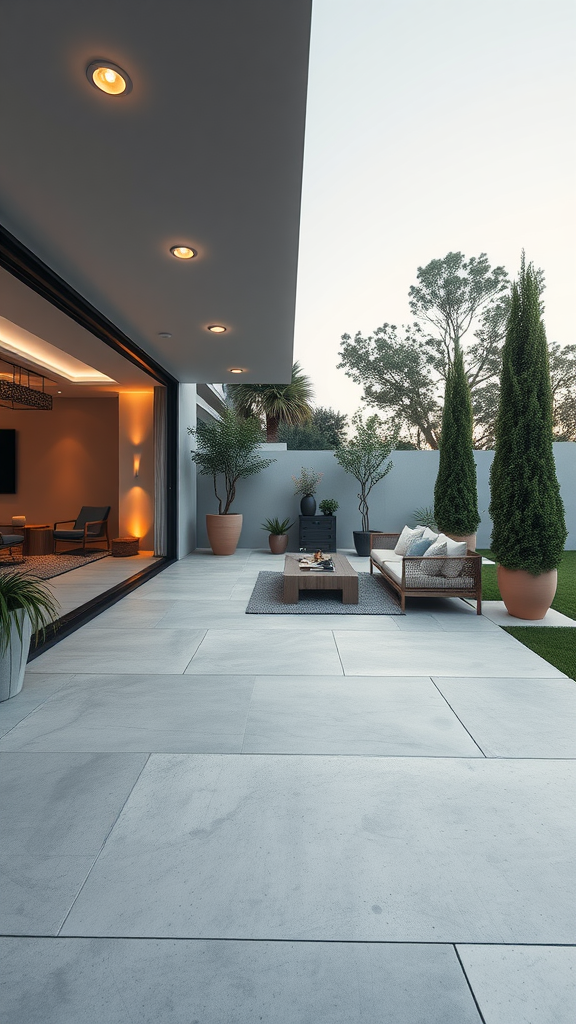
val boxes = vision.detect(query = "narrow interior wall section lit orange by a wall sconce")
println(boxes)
[118,388,154,551]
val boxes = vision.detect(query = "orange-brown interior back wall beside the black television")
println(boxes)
[0,396,118,538]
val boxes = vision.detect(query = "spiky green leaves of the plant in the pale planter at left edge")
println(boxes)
[0,570,58,654]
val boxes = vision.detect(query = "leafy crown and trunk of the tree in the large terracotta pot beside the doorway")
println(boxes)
[188,408,276,515]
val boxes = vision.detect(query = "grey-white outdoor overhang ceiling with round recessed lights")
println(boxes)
[0,0,311,383]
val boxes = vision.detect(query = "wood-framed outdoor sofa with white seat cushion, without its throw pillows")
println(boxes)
[370,534,482,615]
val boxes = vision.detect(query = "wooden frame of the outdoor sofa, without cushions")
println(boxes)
[370,534,482,615]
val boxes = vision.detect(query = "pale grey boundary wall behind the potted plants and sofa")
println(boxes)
[198,442,576,551]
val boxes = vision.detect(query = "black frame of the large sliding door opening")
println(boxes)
[0,224,178,657]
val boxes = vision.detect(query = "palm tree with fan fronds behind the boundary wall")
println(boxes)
[225,362,314,443]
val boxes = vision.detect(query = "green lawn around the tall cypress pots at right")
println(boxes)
[479,548,576,679]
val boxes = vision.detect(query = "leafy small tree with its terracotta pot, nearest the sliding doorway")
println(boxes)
[188,408,276,555]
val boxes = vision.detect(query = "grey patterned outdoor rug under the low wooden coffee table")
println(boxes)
[246,572,404,615]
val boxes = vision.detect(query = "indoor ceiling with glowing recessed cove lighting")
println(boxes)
[0,267,156,397]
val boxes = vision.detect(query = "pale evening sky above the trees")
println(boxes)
[294,0,576,415]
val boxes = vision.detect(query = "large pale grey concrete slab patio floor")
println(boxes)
[0,550,576,1024]
